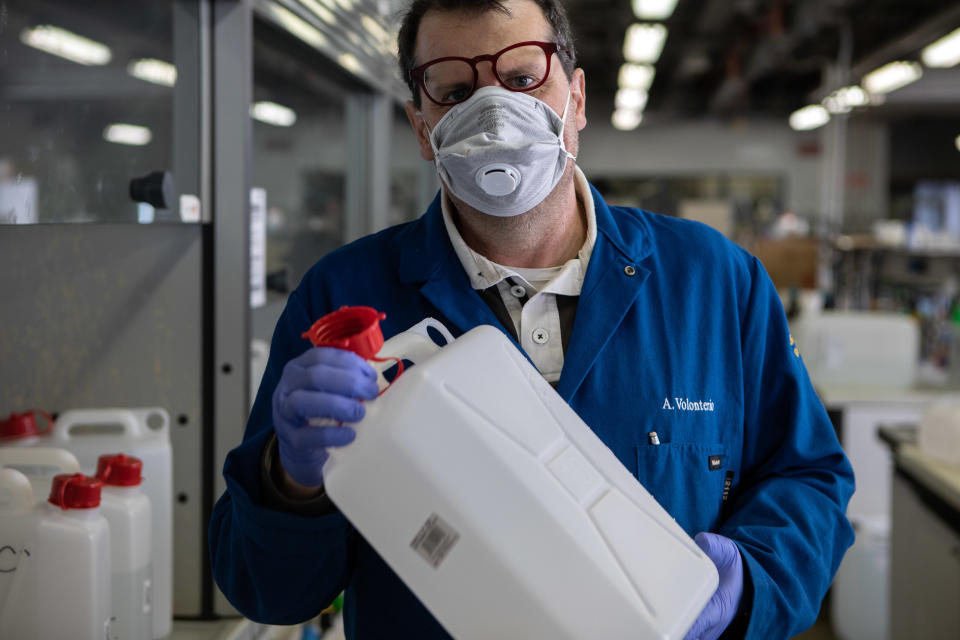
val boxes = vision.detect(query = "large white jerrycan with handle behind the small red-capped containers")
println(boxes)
[43,407,173,638]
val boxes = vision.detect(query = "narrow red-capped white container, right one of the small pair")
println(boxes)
[97,453,153,640]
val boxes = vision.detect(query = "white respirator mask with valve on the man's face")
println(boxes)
[421,86,576,217]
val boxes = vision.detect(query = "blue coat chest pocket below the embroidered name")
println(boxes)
[637,442,730,536]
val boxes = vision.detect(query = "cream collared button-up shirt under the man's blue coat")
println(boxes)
[440,167,597,382]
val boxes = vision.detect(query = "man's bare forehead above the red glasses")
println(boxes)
[415,0,553,64]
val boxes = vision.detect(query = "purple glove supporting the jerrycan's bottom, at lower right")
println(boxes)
[685,532,743,640]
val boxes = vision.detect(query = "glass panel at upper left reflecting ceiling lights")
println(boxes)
[0,0,181,224]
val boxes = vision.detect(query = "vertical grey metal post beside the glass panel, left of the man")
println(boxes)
[211,0,253,614]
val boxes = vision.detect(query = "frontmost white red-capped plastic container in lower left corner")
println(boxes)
[0,469,112,640]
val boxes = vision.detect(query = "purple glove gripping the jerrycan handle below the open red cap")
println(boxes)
[273,347,379,487]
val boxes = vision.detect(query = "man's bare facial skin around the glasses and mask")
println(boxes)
[406,0,587,162]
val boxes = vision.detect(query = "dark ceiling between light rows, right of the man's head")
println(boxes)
[565,0,960,119]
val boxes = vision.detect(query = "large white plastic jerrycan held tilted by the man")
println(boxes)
[324,319,718,640]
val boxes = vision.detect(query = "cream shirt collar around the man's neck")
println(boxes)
[440,165,597,295]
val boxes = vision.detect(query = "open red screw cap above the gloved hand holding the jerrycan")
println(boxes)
[301,307,403,384]
